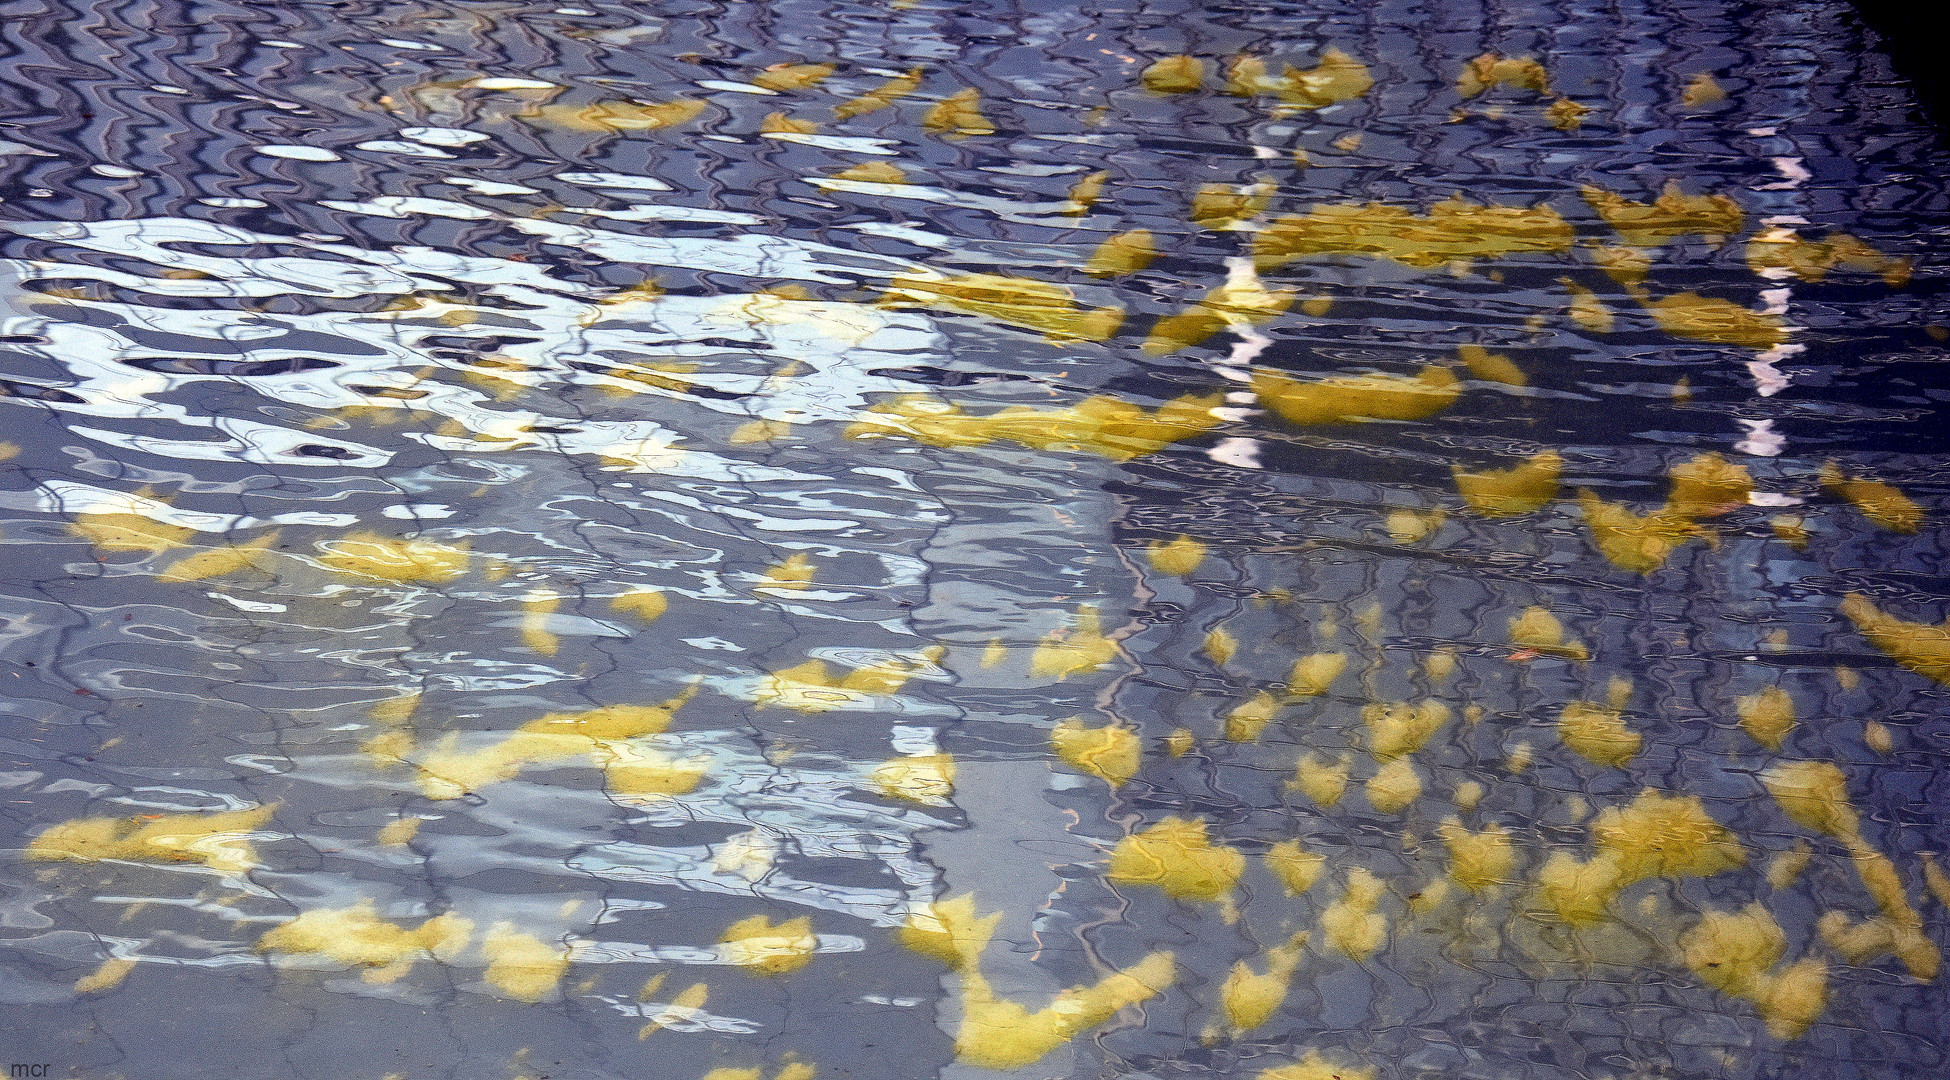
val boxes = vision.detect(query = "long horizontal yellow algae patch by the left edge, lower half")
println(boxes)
[27,807,277,873]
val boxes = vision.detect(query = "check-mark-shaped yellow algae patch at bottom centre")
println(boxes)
[956,953,1178,1068]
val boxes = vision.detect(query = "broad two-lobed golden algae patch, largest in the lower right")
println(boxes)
[1537,788,1747,922]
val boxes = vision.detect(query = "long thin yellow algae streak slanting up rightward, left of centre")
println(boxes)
[417,686,698,799]
